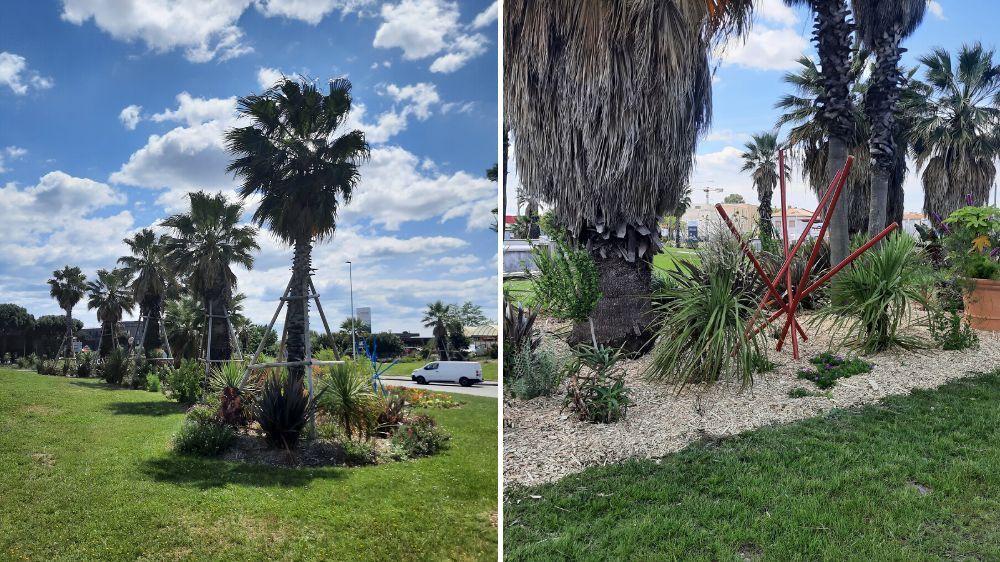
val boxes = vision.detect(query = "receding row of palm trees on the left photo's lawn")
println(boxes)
[49,78,369,377]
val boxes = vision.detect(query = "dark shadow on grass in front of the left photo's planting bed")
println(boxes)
[141,453,348,490]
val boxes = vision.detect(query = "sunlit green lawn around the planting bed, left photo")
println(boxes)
[0,370,497,560]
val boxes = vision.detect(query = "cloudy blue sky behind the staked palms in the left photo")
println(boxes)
[0,0,497,331]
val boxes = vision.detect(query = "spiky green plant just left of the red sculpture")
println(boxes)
[646,257,765,388]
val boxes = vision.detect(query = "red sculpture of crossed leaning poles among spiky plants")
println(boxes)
[715,150,899,359]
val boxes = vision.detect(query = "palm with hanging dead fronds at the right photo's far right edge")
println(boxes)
[908,43,1000,220]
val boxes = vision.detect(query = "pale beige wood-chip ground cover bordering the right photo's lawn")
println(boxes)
[503,312,1000,486]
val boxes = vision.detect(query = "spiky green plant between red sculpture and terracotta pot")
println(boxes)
[814,233,933,353]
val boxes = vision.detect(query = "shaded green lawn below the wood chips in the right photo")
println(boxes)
[504,371,1000,560]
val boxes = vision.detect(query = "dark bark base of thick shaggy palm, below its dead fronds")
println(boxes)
[568,248,653,352]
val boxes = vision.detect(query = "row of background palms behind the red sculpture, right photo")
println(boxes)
[742,43,1000,235]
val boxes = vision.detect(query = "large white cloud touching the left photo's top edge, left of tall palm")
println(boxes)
[62,0,253,62]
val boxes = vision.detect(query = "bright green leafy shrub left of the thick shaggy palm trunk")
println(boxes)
[531,237,601,322]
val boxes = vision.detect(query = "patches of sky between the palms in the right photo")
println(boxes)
[508,0,1000,213]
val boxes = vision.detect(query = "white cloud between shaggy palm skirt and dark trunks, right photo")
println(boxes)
[718,25,809,70]
